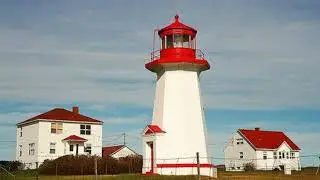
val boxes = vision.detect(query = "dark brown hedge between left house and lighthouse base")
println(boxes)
[39,155,142,175]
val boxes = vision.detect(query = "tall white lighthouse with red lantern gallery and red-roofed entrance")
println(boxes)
[142,15,215,176]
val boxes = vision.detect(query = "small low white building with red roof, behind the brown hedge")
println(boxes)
[102,145,139,159]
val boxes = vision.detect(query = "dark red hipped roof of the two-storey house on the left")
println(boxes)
[18,108,102,125]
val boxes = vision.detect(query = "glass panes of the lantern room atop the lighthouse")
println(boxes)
[161,34,195,49]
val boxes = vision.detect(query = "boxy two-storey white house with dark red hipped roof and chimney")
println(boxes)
[16,107,103,169]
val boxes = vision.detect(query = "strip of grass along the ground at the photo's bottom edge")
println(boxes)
[0,168,320,180]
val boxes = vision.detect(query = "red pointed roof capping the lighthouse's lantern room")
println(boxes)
[159,15,197,36]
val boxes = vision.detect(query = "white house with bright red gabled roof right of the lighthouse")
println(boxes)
[224,128,301,171]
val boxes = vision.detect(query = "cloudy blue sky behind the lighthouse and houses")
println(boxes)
[0,0,320,165]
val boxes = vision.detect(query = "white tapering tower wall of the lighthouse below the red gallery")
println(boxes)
[144,66,210,176]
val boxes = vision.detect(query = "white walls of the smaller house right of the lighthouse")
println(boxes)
[224,132,301,171]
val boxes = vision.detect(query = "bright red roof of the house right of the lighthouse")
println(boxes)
[238,128,300,150]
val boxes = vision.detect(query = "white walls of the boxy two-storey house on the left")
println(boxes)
[17,121,102,168]
